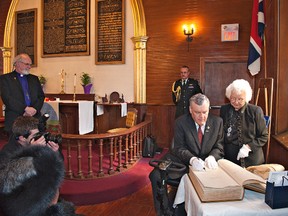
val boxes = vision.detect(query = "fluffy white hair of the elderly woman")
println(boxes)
[225,79,252,103]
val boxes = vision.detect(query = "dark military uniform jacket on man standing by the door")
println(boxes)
[172,78,202,118]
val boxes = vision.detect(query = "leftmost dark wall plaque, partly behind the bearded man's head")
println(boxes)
[15,8,37,66]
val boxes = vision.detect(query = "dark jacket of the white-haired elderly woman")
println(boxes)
[220,104,268,167]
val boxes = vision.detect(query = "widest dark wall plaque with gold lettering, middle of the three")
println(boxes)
[42,0,90,57]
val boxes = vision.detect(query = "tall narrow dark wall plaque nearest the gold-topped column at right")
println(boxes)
[96,0,125,64]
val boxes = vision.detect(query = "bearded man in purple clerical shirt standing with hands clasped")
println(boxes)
[0,53,45,134]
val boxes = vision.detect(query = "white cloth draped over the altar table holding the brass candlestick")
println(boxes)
[45,100,94,135]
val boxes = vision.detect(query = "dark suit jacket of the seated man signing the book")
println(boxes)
[172,114,224,166]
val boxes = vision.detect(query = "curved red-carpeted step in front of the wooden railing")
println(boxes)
[60,150,167,205]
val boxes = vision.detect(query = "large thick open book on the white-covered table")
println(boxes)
[189,159,266,202]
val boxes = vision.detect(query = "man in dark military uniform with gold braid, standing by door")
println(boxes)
[172,65,202,119]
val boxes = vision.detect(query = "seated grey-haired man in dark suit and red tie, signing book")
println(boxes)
[149,93,224,216]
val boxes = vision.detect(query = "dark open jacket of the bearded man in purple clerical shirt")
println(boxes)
[0,71,45,132]
